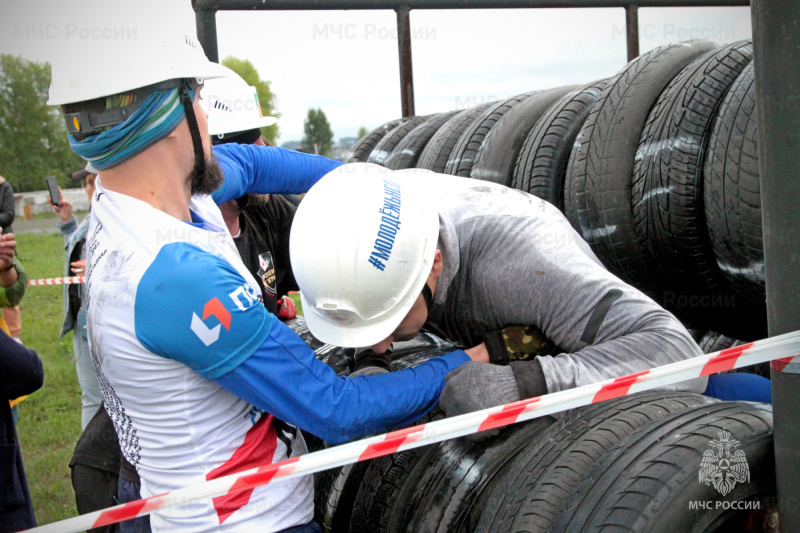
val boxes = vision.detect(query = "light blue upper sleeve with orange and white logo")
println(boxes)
[134,242,277,379]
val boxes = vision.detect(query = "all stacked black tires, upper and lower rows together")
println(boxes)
[328,36,777,533]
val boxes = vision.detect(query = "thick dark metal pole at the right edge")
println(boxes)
[751,0,800,533]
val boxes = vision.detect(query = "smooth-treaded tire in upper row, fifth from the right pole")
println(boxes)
[470,85,576,185]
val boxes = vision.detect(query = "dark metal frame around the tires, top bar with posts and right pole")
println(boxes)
[192,0,800,533]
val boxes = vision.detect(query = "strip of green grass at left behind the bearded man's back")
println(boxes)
[16,234,81,525]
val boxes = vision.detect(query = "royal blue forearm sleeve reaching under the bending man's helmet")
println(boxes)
[214,324,469,443]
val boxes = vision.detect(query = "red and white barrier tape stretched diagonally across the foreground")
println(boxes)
[23,331,800,533]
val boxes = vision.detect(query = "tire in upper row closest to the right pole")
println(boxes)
[704,65,766,322]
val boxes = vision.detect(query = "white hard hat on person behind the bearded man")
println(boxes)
[202,66,278,135]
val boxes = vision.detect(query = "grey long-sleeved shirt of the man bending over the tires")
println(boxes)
[412,171,707,393]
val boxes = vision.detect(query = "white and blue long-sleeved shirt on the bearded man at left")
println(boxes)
[86,145,468,531]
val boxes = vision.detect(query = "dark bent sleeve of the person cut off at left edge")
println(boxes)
[0,331,44,400]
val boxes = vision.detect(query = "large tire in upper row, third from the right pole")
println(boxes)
[565,41,718,294]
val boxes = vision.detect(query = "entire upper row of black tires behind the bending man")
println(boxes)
[349,40,766,340]
